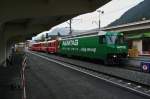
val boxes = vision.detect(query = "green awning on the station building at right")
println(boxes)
[127,32,150,40]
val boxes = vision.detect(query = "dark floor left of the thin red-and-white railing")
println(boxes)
[0,54,23,99]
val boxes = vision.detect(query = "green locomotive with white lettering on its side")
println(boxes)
[58,31,128,64]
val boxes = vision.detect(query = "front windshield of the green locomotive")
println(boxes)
[106,35,124,44]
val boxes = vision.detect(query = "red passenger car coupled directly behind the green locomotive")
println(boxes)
[47,40,59,53]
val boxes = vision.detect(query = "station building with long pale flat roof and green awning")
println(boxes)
[101,20,150,57]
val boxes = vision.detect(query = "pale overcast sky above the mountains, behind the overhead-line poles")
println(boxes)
[54,0,144,30]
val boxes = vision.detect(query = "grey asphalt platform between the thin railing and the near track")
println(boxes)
[26,53,146,99]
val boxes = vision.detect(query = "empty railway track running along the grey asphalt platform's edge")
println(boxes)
[29,52,150,98]
